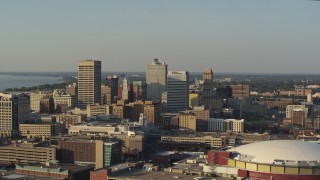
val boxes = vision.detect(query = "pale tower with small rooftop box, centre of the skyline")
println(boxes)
[146,59,168,101]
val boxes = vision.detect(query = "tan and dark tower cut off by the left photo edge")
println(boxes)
[0,93,30,137]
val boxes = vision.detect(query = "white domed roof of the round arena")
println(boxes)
[228,140,320,164]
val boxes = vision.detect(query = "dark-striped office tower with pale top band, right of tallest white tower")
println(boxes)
[167,71,189,112]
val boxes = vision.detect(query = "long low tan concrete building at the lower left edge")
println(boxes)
[0,144,56,163]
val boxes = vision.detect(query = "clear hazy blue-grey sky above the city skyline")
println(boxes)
[0,0,320,73]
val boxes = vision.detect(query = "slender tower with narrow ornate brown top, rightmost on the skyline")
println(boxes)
[201,68,214,109]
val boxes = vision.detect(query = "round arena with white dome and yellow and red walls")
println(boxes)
[208,140,320,180]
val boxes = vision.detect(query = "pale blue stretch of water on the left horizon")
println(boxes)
[0,74,62,91]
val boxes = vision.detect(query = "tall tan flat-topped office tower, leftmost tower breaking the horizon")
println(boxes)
[78,59,101,109]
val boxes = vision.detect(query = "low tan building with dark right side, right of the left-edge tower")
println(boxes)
[19,123,65,138]
